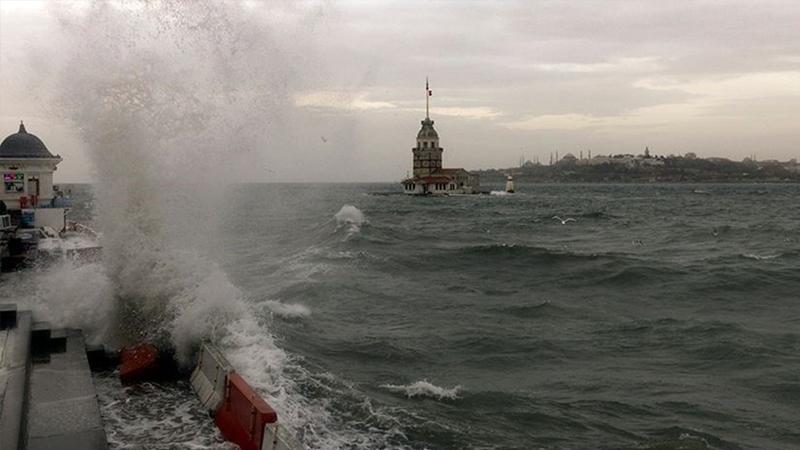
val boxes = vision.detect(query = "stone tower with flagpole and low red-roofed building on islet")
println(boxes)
[402,80,480,195]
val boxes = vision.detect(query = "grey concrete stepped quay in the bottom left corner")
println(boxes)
[0,305,108,450]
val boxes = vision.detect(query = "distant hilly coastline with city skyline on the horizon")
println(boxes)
[474,151,800,183]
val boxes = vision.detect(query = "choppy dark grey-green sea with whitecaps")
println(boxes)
[9,184,800,450]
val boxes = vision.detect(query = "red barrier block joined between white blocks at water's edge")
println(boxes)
[214,372,278,450]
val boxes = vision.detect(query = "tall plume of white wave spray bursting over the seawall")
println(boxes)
[17,0,396,448]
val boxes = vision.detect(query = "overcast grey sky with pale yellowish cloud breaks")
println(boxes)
[0,0,800,182]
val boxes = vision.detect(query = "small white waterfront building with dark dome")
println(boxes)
[0,122,61,211]
